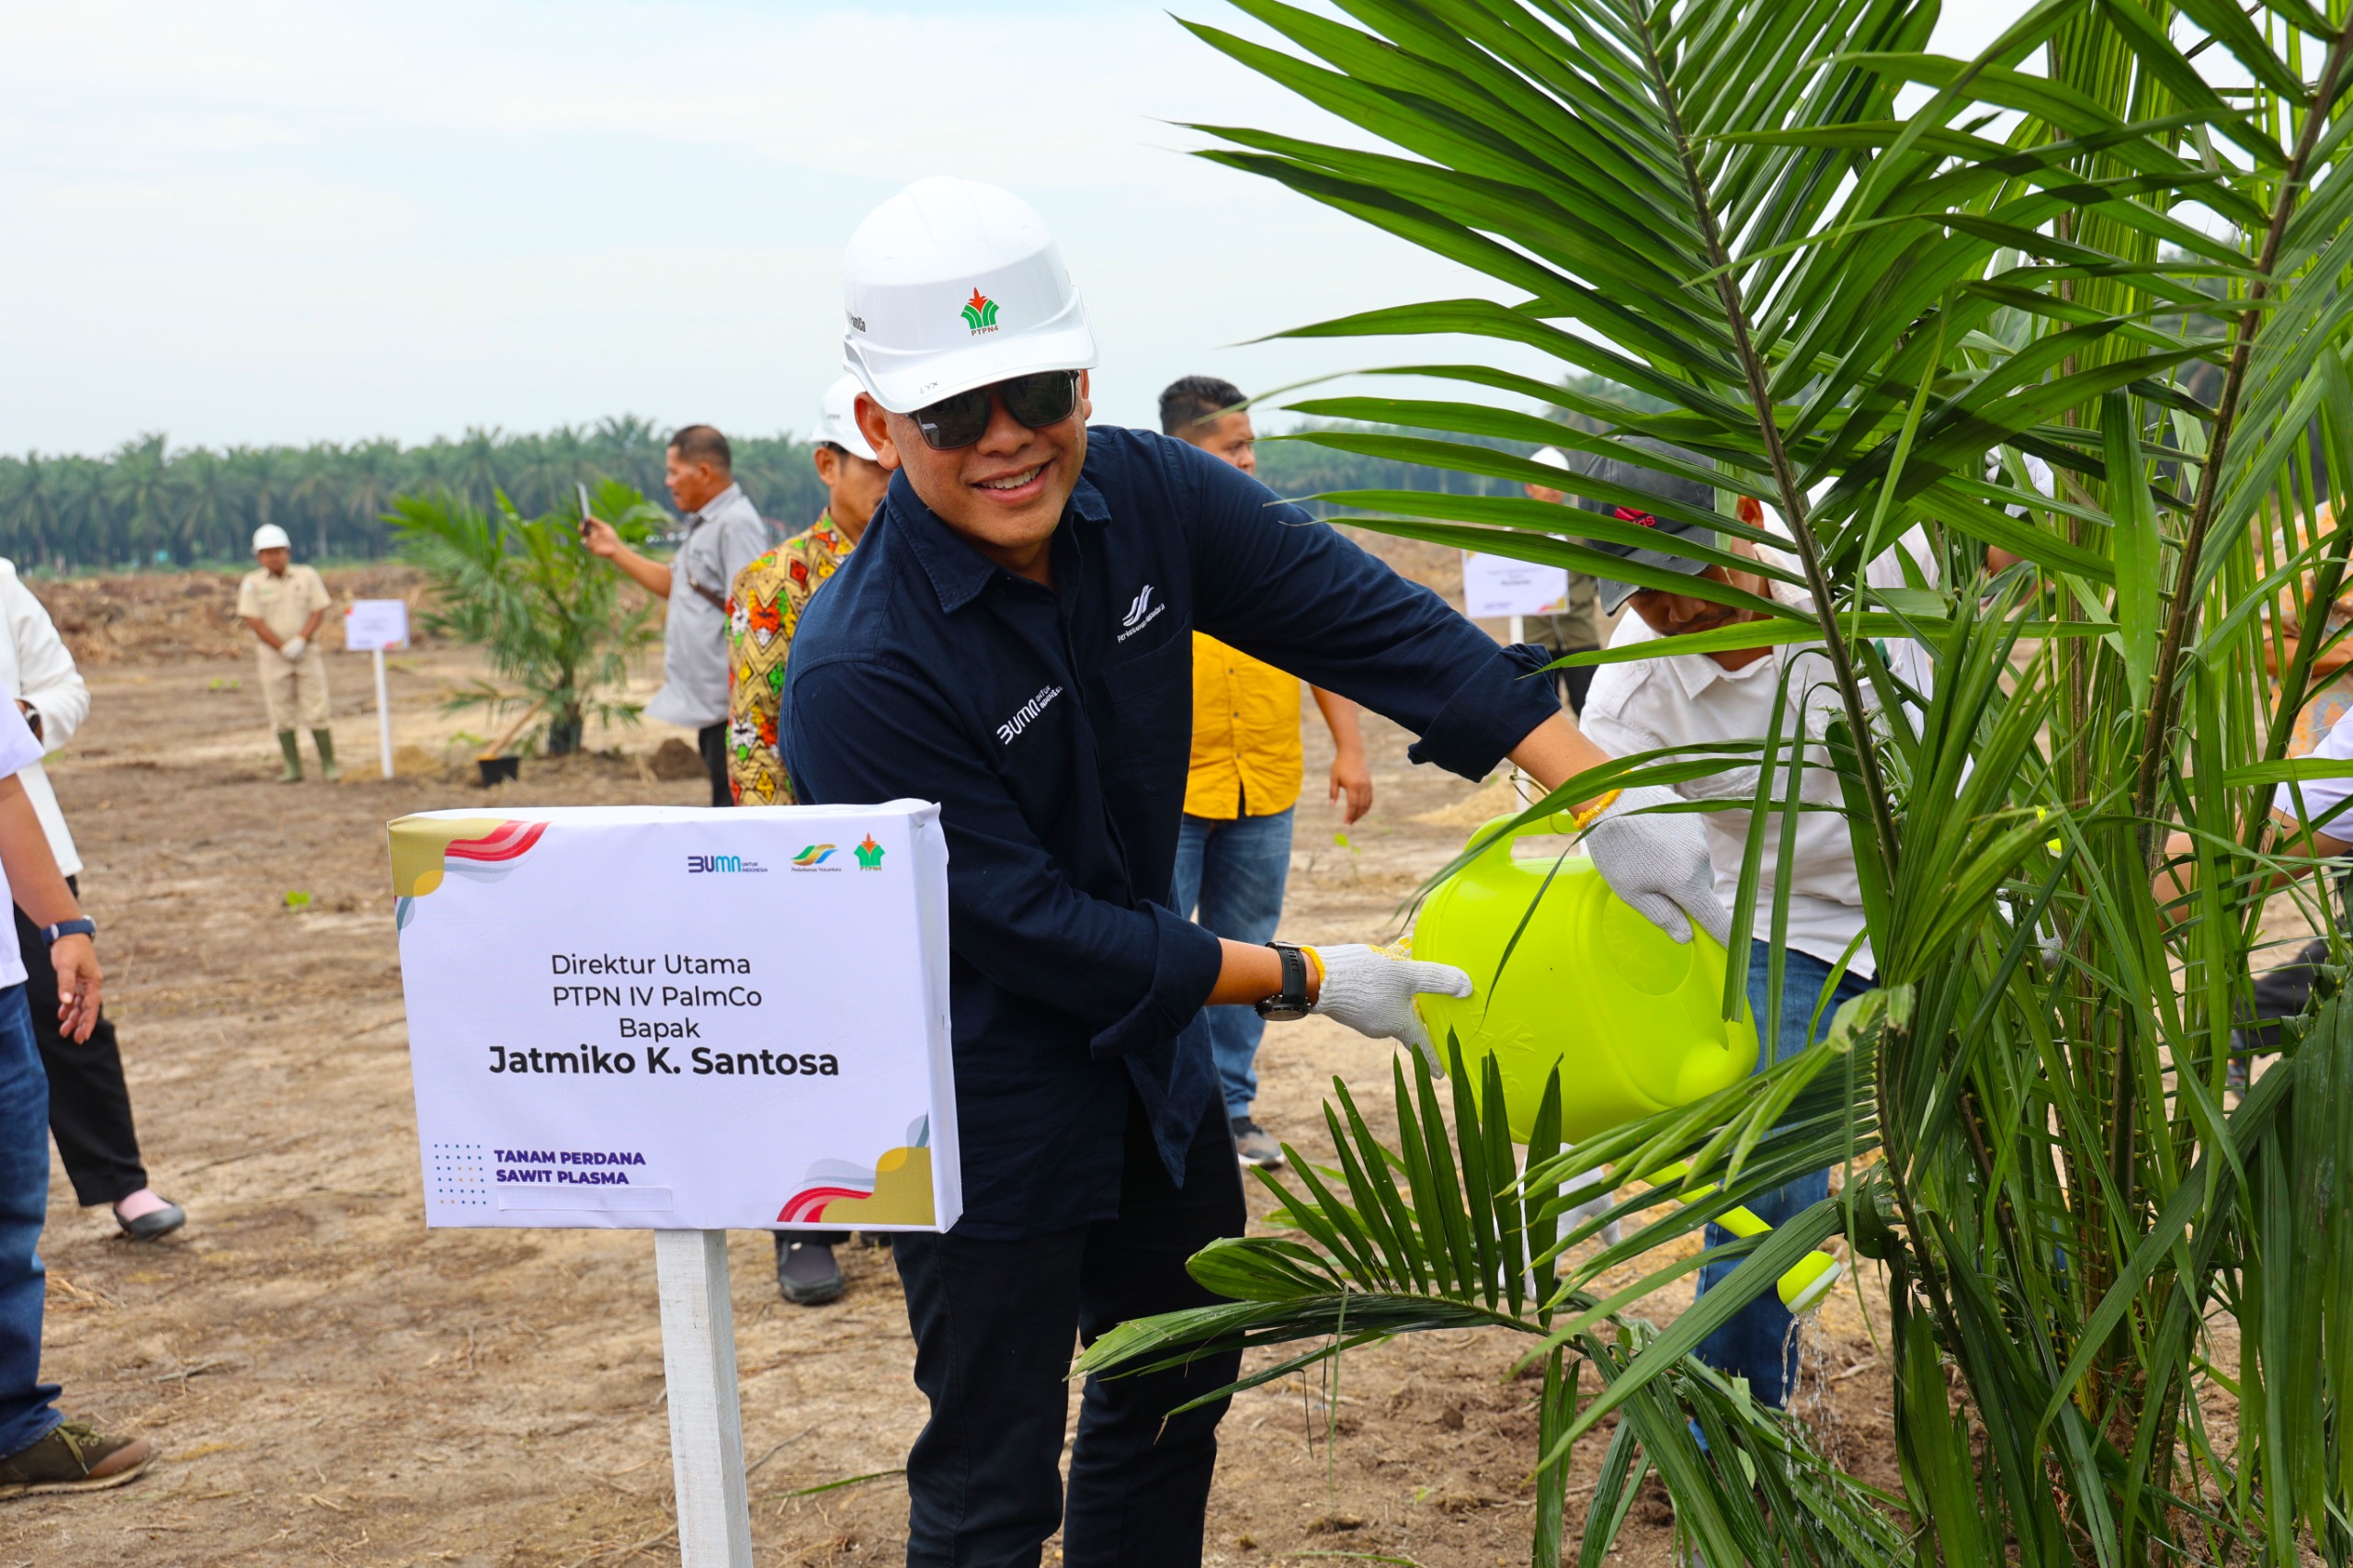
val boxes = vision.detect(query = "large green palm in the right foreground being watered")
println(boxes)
[1083,0,2353,1568]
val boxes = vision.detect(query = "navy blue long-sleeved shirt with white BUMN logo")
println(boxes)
[781,426,1560,1238]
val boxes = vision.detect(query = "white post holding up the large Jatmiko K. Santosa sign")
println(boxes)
[654,1232,751,1568]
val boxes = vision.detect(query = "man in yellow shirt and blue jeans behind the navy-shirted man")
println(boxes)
[1160,377,1371,1165]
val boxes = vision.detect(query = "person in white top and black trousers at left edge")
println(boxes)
[0,561,188,1241]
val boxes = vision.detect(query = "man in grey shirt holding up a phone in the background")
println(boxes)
[581,424,769,805]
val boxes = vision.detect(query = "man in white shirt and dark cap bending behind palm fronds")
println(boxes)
[1572,443,1927,1405]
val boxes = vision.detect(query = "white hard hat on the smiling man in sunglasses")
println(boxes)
[842,179,1094,414]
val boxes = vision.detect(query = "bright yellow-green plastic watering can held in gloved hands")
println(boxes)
[1415,812,1840,1313]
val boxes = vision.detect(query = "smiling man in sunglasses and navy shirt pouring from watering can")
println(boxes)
[783,179,1722,1568]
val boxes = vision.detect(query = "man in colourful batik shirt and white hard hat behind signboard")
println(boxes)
[727,377,890,1307]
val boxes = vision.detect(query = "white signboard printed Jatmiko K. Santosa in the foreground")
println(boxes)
[391,801,962,1232]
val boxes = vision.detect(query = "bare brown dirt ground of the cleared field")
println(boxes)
[0,567,1894,1568]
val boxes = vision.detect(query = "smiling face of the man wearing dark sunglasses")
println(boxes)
[858,372,1092,582]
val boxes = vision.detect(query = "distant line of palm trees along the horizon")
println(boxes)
[0,415,1520,574]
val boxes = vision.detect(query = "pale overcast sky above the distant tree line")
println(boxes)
[0,0,2021,452]
